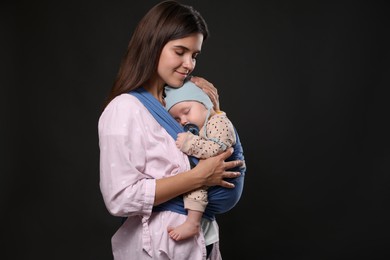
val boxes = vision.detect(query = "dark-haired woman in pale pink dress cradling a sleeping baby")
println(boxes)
[98,1,243,260]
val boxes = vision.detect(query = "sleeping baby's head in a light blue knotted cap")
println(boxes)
[165,81,213,128]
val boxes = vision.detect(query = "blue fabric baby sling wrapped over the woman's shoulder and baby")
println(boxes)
[129,87,246,220]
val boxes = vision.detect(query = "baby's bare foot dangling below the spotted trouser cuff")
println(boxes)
[168,210,203,241]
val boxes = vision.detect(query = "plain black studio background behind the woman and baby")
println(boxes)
[0,0,390,260]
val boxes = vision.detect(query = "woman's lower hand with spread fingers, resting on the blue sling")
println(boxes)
[195,148,243,188]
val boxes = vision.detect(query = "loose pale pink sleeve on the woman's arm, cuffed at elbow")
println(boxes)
[98,95,156,216]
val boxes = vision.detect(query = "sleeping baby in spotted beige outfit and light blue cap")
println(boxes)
[165,81,236,241]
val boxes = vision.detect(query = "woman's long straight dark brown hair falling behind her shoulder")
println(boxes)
[104,1,209,107]
